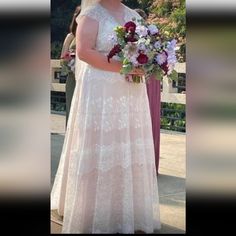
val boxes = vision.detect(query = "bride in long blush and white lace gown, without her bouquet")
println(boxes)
[51,0,160,234]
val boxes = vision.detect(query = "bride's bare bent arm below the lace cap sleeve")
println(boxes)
[76,16,122,72]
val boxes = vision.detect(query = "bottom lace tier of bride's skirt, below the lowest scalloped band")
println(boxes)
[60,164,160,234]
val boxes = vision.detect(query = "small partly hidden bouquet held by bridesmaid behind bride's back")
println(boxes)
[60,49,75,76]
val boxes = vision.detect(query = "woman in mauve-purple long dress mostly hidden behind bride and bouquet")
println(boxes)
[135,9,161,174]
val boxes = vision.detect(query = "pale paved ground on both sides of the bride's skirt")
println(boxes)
[51,114,186,234]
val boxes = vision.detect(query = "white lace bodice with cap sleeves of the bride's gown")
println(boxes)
[77,3,141,53]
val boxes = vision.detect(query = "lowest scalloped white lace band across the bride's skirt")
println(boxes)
[71,139,155,175]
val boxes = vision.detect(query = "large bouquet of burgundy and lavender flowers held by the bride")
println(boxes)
[107,19,177,83]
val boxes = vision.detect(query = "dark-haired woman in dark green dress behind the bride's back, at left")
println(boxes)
[61,6,81,125]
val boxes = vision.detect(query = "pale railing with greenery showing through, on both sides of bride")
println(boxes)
[51,60,186,132]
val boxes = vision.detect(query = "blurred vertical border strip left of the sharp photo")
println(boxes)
[0,0,50,234]
